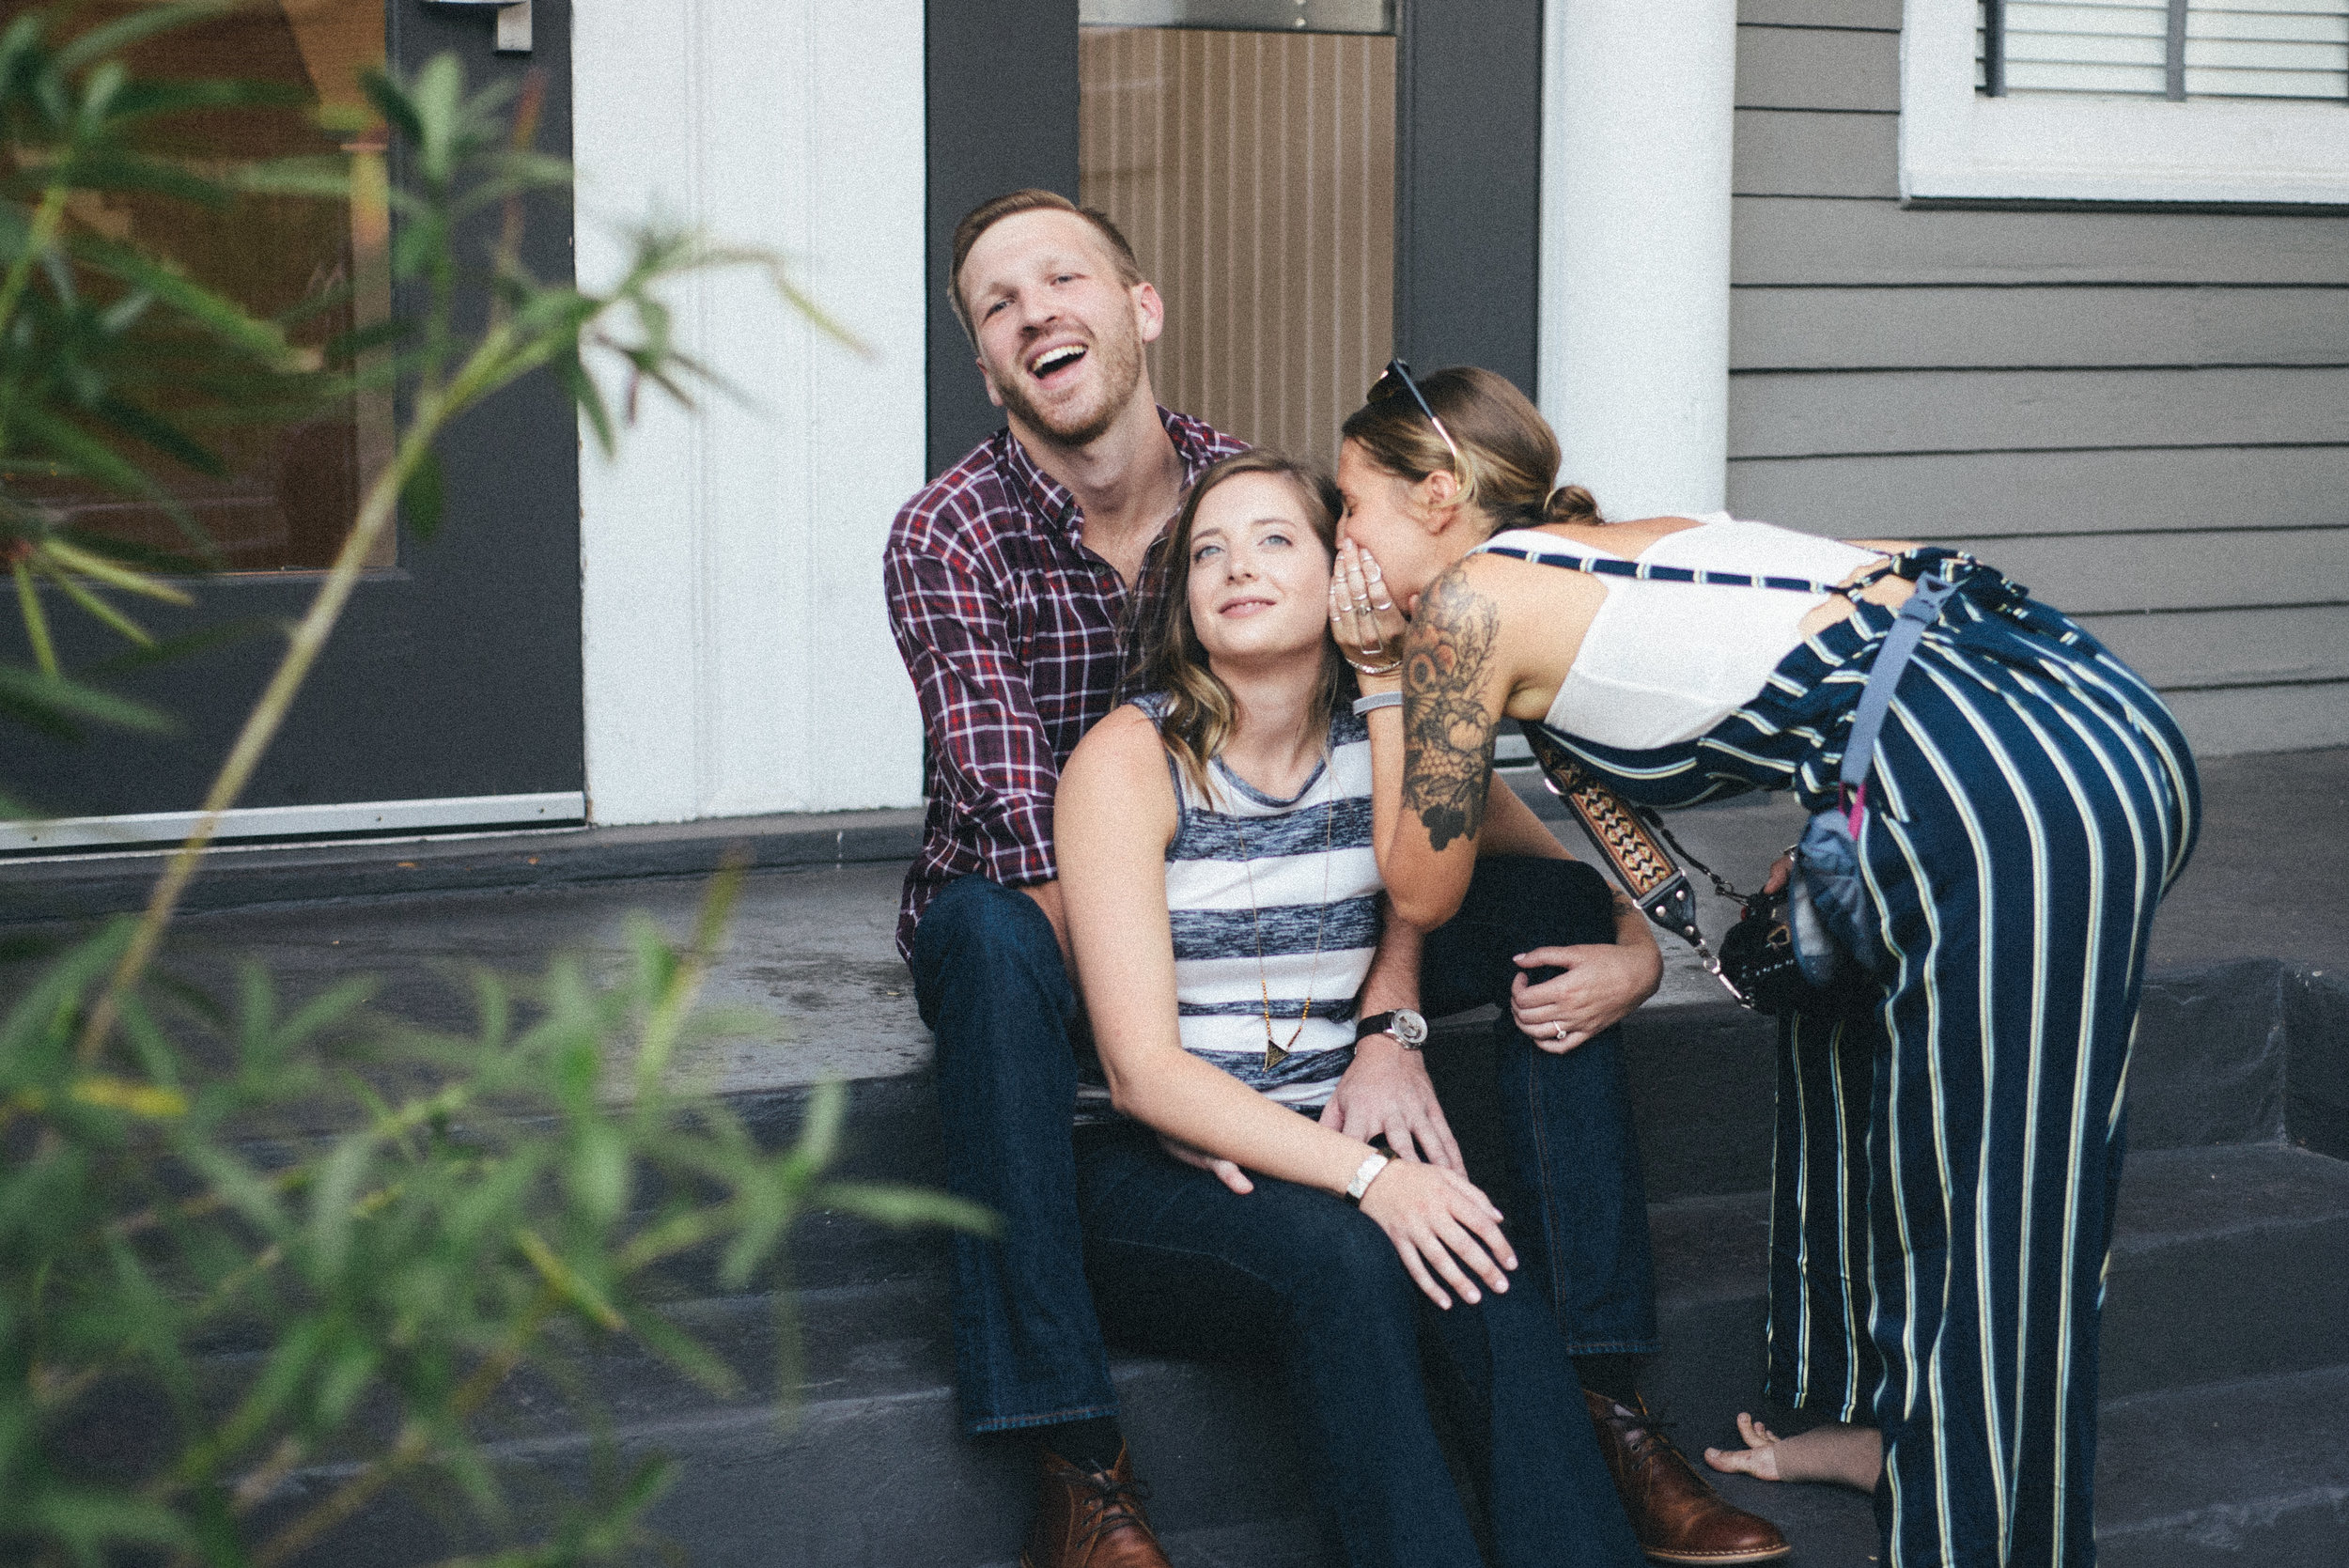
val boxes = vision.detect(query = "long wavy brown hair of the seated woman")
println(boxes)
[1126,446,1351,800]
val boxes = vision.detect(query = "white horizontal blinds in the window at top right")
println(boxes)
[1973,0,2349,101]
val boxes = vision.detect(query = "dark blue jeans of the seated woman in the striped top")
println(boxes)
[1076,1125,1642,1568]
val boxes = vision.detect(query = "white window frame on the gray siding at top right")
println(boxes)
[1901,0,2349,207]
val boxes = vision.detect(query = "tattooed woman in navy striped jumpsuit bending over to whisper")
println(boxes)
[1332,364,2197,1568]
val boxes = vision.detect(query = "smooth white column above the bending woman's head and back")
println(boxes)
[1539,0,1738,519]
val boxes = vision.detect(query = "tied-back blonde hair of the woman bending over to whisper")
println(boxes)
[1342,364,1607,533]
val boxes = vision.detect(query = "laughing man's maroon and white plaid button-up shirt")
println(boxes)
[881,409,1245,960]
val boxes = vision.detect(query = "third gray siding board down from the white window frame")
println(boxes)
[1729,366,2349,458]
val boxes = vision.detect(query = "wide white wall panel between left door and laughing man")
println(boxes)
[573,0,926,824]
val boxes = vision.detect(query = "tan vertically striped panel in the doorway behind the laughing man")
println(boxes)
[1079,28,1395,462]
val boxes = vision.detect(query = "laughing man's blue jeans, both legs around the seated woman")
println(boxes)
[914,857,1657,1435]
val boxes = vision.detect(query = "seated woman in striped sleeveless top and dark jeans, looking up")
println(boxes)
[1055,453,1644,1568]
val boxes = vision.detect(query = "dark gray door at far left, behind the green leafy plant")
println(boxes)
[9,0,585,821]
